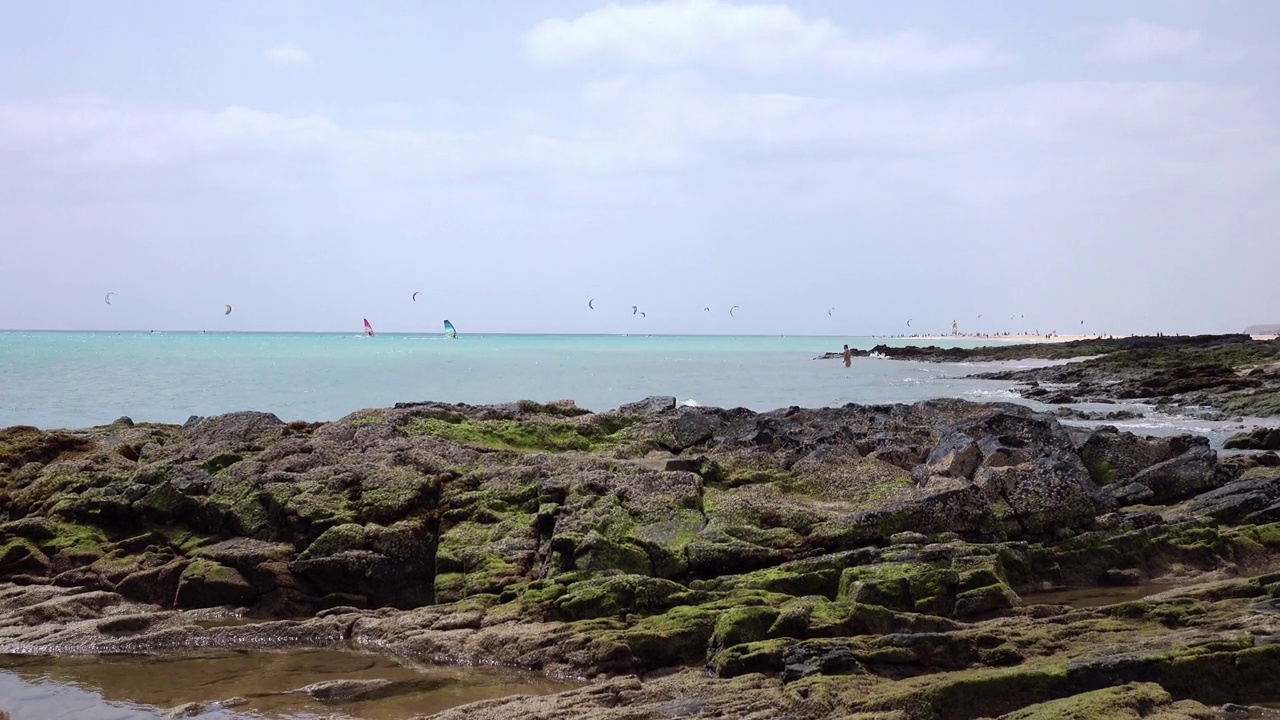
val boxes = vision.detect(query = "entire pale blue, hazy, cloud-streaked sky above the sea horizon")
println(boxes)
[0,0,1280,336]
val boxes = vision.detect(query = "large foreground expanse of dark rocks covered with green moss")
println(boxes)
[0,394,1280,720]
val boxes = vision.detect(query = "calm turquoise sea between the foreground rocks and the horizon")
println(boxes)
[0,332,1264,436]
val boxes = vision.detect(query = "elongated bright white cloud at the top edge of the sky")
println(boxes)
[526,0,1009,76]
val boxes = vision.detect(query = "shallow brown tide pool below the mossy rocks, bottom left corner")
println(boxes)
[0,650,579,720]
